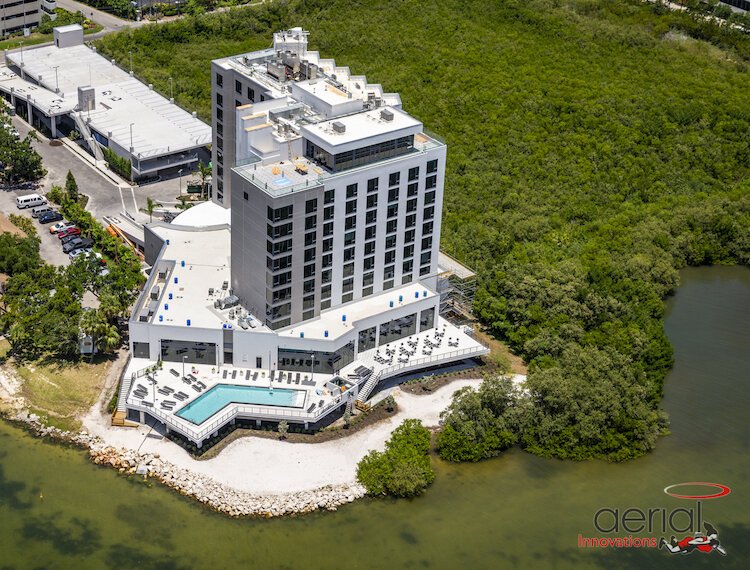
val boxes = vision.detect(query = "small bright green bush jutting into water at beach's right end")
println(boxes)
[357,420,435,497]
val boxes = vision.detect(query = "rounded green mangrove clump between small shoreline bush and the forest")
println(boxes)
[437,377,528,461]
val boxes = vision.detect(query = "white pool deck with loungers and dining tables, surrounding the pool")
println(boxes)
[120,318,489,444]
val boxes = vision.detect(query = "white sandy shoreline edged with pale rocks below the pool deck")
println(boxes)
[1,375,524,518]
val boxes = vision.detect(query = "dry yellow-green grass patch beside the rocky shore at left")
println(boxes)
[14,352,112,429]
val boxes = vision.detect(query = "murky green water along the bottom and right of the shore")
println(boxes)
[0,268,750,570]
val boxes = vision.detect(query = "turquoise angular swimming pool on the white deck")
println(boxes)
[176,384,305,425]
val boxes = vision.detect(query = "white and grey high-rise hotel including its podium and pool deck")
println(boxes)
[118,28,488,445]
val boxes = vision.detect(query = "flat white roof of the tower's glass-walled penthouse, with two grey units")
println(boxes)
[300,107,422,146]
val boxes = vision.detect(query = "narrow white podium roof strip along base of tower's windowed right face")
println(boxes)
[276,283,436,339]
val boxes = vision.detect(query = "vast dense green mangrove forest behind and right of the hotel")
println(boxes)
[99,0,750,460]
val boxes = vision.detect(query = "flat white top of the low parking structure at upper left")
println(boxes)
[7,45,211,158]
